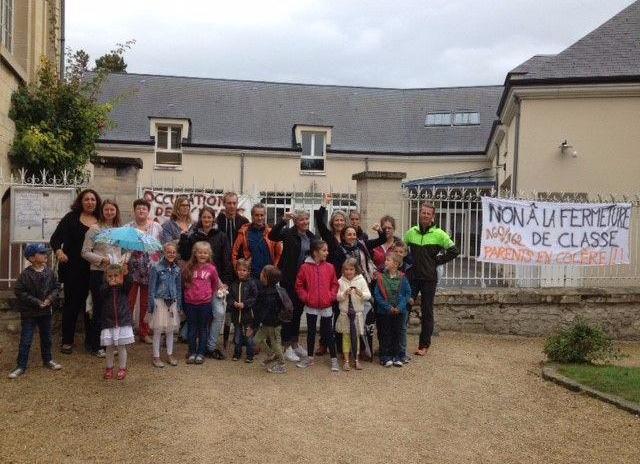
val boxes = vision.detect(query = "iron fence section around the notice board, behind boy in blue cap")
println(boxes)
[0,168,90,288]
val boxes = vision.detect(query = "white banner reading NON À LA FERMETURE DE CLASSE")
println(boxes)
[478,197,631,266]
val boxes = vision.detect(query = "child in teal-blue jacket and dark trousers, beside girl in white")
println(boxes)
[374,253,411,367]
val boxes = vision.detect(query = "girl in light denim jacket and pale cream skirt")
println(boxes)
[147,242,182,367]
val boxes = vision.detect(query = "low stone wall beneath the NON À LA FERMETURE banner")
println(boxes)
[430,288,640,340]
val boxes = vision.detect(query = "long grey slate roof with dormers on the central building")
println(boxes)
[101,74,503,154]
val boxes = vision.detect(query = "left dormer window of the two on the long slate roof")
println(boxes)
[151,119,189,169]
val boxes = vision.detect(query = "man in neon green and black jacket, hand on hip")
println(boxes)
[404,203,458,356]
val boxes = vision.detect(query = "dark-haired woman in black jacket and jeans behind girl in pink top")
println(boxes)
[178,206,233,359]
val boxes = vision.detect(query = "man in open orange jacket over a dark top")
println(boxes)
[231,203,282,279]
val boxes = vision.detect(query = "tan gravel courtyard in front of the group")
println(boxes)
[0,333,640,464]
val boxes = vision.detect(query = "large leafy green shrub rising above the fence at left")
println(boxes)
[9,42,133,177]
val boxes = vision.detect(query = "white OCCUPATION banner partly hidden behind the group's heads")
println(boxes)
[142,189,253,224]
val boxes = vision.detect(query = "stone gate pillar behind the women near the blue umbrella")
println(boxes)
[91,156,142,223]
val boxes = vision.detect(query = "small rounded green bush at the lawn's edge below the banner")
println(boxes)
[544,319,619,364]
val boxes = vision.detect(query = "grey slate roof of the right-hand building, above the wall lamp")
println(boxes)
[507,1,640,84]
